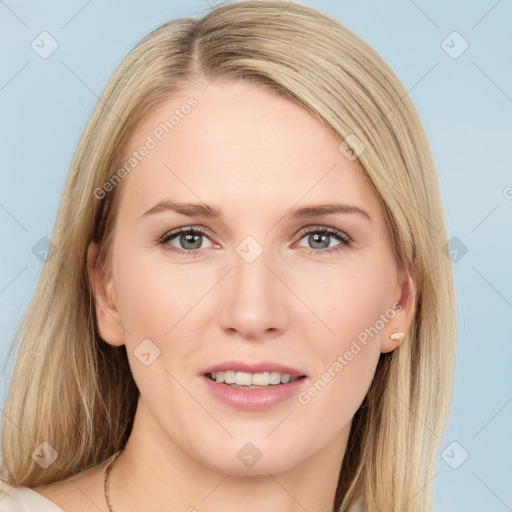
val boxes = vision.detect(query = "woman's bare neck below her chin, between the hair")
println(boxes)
[109,401,350,512]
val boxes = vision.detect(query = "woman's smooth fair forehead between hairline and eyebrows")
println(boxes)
[114,81,379,222]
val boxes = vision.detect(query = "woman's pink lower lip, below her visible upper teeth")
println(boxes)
[202,375,308,411]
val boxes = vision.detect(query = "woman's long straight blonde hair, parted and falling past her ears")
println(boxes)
[2,0,456,512]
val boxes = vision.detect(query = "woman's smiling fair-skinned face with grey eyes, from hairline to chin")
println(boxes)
[90,81,412,474]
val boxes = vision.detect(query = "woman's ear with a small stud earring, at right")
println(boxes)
[381,269,418,353]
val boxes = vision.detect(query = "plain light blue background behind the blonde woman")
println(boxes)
[0,0,512,512]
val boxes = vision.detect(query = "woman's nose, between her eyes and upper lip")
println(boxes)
[219,247,293,341]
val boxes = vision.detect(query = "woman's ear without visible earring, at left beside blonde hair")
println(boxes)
[87,242,124,346]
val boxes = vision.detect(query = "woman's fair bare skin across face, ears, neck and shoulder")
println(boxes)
[35,81,415,512]
